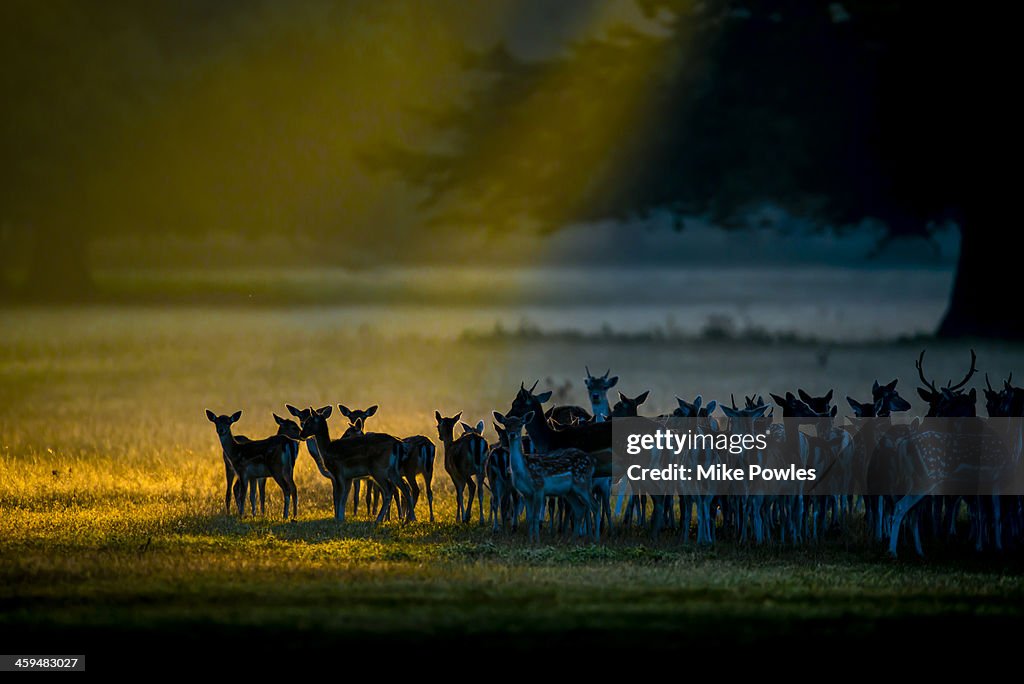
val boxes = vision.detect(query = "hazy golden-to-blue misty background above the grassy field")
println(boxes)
[0,0,991,341]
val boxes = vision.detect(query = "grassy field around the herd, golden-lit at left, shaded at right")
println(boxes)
[0,308,1024,654]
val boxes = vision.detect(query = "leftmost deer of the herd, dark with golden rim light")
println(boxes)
[206,409,299,520]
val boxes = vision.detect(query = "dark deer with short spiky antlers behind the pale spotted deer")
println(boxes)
[508,382,617,527]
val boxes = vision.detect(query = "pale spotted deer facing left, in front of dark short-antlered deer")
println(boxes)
[494,411,601,542]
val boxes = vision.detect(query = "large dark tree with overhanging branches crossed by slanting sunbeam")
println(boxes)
[365,0,1024,338]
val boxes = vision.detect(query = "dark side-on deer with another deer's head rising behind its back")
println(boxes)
[299,405,416,523]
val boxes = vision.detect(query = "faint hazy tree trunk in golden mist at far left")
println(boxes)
[22,229,95,302]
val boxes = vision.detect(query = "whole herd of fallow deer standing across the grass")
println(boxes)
[206,351,1024,555]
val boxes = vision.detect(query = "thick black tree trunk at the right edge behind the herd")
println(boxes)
[937,206,1024,340]
